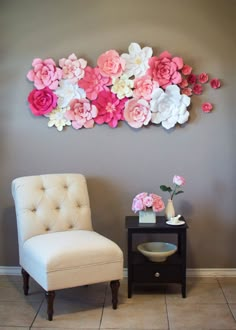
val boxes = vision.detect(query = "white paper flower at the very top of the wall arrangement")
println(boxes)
[121,42,152,78]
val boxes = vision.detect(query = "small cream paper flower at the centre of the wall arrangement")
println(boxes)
[111,74,134,100]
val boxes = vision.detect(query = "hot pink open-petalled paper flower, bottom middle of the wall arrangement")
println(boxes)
[92,91,127,128]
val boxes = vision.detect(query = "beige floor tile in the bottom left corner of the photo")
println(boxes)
[0,301,41,327]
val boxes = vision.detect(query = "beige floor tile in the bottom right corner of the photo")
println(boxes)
[167,303,236,330]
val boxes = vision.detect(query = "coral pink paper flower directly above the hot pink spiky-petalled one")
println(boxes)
[78,66,111,101]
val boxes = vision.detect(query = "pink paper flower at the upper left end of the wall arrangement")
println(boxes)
[27,58,62,90]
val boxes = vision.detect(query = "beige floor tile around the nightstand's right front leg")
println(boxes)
[166,281,226,304]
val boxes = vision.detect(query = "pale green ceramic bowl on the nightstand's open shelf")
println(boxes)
[137,242,177,262]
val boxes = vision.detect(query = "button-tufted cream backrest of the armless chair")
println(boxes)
[12,174,93,248]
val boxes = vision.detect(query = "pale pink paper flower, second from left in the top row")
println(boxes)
[59,53,87,83]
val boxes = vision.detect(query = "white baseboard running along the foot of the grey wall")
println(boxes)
[0,266,236,277]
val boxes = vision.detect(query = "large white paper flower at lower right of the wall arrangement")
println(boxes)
[150,85,190,129]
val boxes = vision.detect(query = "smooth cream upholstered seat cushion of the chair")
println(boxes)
[21,230,123,290]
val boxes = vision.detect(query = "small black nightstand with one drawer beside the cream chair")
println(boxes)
[125,216,188,298]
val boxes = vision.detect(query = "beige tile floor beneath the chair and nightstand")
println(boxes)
[0,276,236,330]
